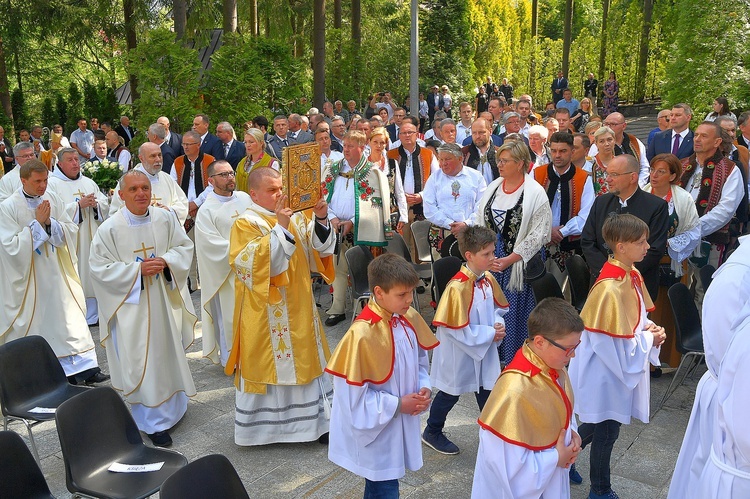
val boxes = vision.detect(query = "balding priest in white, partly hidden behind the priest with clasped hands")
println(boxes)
[109,142,188,225]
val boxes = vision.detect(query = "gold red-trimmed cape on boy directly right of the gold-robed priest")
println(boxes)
[326,299,440,386]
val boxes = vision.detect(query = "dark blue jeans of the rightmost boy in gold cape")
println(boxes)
[578,419,621,495]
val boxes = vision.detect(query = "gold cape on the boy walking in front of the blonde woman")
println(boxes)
[432,265,508,329]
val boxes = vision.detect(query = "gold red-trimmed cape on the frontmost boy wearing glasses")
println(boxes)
[478,340,573,451]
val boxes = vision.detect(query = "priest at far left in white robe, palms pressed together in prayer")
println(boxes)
[0,160,109,383]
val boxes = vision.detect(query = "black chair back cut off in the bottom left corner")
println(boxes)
[0,431,54,499]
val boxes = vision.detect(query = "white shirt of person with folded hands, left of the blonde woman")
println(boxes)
[422,166,487,229]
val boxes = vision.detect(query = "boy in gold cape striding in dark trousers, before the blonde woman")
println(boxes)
[422,227,508,454]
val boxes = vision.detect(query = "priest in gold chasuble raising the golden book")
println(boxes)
[224,167,336,445]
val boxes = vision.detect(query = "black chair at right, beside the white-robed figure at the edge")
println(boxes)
[659,282,706,409]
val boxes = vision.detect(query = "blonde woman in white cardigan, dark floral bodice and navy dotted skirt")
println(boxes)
[468,141,552,365]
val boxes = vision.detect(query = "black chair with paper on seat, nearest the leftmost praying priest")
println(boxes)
[0,336,89,466]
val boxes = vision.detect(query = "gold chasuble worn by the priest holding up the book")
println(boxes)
[224,208,334,394]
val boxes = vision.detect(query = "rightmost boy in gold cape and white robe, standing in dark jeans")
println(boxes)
[569,214,666,499]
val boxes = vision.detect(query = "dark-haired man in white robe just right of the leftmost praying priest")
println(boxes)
[49,147,109,325]
